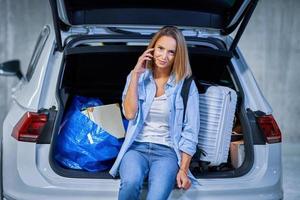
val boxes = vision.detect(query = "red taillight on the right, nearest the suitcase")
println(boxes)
[257,115,281,144]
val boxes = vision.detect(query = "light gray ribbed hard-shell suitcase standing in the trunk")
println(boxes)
[181,79,237,166]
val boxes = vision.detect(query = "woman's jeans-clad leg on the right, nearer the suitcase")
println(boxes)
[147,144,179,200]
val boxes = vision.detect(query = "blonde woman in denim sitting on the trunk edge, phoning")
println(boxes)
[110,26,199,200]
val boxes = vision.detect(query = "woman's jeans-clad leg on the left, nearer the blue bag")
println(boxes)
[119,144,149,200]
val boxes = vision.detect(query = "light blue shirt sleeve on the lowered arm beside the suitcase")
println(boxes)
[179,81,200,156]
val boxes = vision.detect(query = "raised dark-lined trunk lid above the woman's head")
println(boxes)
[49,0,258,51]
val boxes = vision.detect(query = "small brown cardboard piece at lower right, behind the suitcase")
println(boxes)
[230,140,245,168]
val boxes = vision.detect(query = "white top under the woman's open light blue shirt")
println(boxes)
[135,94,172,147]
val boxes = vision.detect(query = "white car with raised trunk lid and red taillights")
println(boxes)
[0,0,283,200]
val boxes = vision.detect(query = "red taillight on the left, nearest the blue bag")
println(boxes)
[12,112,48,142]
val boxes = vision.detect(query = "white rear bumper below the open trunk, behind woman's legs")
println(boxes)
[3,140,283,200]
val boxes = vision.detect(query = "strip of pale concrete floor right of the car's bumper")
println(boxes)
[282,143,300,200]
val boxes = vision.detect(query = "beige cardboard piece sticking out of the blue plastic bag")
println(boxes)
[82,103,125,139]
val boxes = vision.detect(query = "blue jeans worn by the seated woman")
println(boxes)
[119,142,179,200]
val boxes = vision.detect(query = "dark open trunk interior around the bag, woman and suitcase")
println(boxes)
[50,38,252,179]
